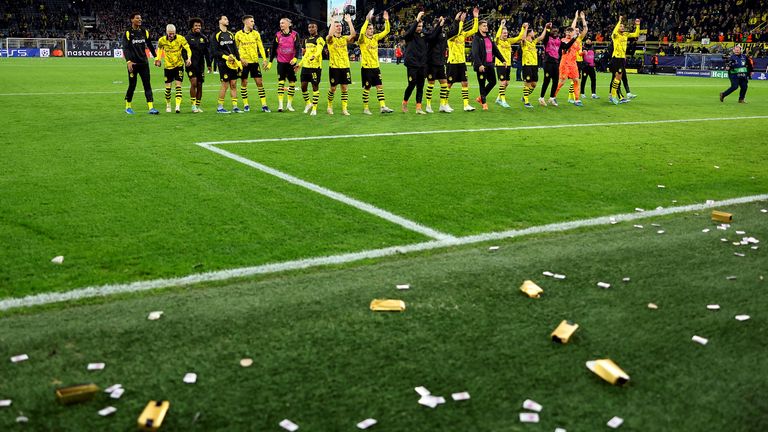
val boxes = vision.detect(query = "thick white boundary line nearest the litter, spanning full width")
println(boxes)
[0,194,768,311]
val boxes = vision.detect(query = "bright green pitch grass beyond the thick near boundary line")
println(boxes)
[0,59,768,298]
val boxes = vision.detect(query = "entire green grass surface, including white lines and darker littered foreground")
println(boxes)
[0,59,768,431]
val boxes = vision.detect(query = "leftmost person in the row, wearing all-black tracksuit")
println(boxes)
[122,12,160,115]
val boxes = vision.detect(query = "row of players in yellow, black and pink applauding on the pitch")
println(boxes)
[122,7,640,116]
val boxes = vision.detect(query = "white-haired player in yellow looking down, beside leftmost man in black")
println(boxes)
[155,24,192,114]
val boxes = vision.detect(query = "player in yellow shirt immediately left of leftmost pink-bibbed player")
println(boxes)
[235,15,270,112]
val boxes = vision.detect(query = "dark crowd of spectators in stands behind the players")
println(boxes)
[0,0,768,55]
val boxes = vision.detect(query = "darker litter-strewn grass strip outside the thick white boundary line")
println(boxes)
[0,203,768,431]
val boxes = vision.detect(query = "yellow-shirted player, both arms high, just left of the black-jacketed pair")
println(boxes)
[357,9,392,115]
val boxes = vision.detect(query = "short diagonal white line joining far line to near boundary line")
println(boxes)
[198,144,454,240]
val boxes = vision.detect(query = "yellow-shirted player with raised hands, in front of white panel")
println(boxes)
[326,14,357,115]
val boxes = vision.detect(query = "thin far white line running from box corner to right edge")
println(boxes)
[196,116,768,146]
